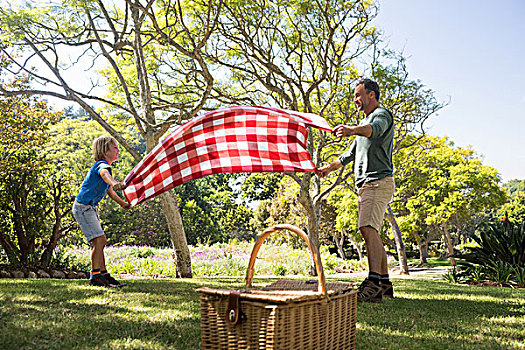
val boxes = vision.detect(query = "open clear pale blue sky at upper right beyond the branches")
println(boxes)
[375,0,525,182]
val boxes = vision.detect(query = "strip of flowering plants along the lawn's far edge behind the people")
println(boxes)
[58,241,366,277]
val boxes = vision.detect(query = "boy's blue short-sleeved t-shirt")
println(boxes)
[76,160,113,207]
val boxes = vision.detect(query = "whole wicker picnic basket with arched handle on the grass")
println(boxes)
[197,224,357,350]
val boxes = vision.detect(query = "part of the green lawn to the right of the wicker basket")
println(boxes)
[348,280,525,350]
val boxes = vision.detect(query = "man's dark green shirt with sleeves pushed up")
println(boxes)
[339,107,394,188]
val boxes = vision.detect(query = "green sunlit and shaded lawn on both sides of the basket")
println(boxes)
[0,278,525,350]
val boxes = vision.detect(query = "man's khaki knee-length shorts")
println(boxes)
[358,176,395,232]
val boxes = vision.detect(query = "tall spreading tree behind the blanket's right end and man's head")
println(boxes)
[208,0,442,272]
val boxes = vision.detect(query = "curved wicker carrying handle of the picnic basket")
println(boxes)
[246,224,326,296]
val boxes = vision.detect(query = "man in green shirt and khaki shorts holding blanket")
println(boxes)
[317,79,394,302]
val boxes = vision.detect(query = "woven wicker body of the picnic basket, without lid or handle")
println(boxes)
[201,291,357,350]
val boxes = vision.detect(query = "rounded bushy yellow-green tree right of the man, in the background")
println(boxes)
[393,137,505,264]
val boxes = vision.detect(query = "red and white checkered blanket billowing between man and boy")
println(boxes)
[124,106,332,206]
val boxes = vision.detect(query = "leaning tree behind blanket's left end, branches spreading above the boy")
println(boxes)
[0,0,221,277]
